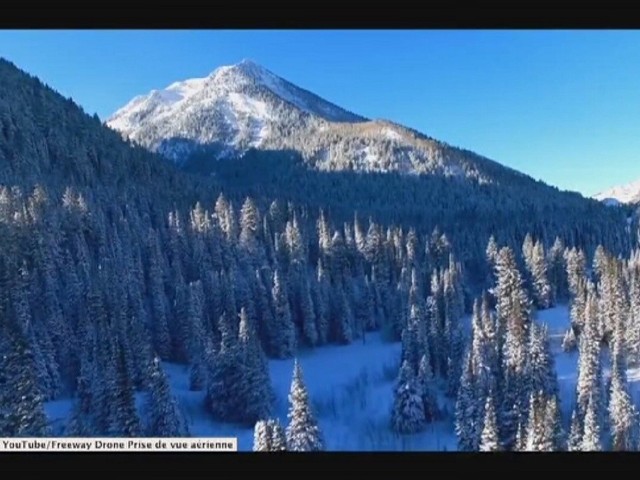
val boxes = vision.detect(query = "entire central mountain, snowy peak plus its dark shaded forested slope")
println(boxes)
[107,61,629,279]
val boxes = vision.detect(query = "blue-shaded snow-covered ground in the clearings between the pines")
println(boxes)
[46,305,640,451]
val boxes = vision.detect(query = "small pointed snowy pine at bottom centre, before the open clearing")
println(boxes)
[286,360,324,452]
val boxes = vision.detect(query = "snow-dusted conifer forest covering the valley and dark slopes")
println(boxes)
[0,60,640,451]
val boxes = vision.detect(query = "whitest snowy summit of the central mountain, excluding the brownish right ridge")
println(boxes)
[107,60,366,161]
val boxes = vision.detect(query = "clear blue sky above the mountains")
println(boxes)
[0,30,640,195]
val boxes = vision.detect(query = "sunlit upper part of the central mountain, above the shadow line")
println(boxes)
[107,60,524,182]
